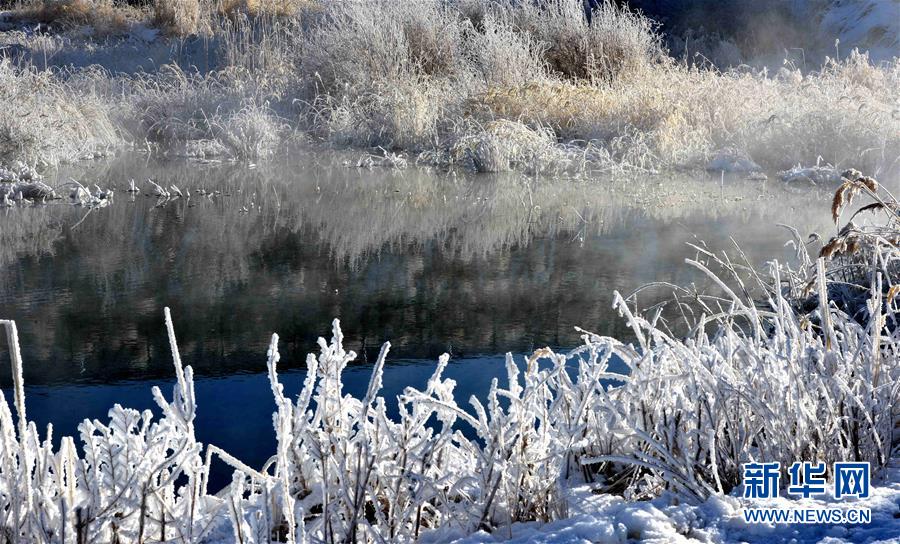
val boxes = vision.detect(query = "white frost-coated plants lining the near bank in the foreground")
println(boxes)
[0,227,900,543]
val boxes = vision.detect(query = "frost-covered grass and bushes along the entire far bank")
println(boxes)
[4,0,900,176]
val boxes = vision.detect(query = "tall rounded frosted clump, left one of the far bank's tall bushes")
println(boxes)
[300,0,468,151]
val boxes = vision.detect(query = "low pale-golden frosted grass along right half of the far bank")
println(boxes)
[472,52,900,175]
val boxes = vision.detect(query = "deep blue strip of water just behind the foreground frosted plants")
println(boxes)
[10,357,608,489]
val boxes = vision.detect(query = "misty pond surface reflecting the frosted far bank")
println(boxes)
[0,151,856,482]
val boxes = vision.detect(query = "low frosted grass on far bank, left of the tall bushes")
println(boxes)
[0,56,286,167]
